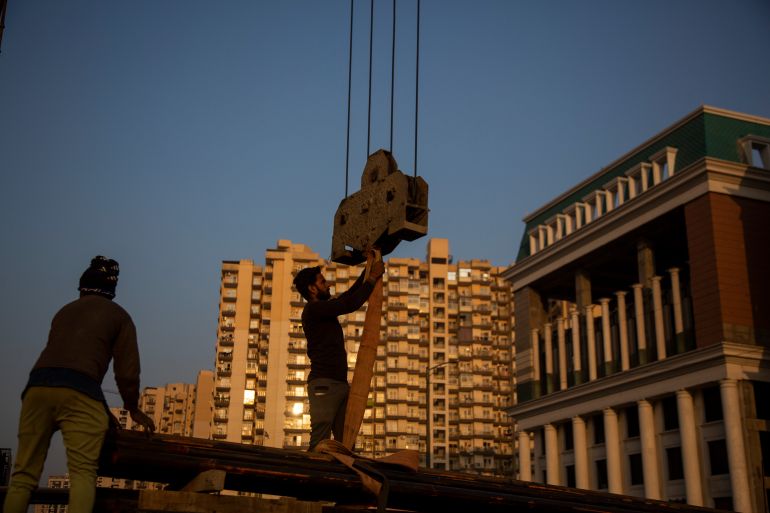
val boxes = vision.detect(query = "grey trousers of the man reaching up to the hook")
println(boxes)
[307,378,350,451]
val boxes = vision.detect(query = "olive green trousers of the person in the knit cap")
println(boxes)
[3,387,109,513]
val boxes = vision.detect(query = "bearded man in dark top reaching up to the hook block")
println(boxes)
[294,250,385,451]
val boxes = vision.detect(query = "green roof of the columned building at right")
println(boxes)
[516,107,770,261]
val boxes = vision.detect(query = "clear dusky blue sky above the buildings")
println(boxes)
[0,0,770,473]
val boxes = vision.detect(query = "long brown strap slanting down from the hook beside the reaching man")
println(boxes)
[342,277,382,450]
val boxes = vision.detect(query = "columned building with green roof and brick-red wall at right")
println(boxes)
[504,107,770,512]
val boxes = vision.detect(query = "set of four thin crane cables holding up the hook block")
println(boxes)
[345,0,420,198]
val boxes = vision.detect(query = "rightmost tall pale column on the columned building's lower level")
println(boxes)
[719,379,752,513]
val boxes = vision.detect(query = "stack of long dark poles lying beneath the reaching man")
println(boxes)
[99,431,728,513]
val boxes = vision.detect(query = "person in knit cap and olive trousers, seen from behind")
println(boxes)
[3,256,155,513]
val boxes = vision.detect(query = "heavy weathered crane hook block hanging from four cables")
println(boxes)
[331,150,428,265]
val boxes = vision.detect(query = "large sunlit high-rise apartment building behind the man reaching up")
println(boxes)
[212,239,513,474]
